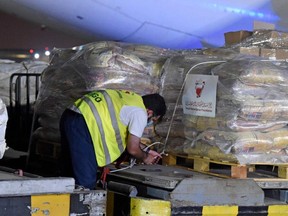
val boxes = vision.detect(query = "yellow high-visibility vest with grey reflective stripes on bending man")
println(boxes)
[74,89,146,167]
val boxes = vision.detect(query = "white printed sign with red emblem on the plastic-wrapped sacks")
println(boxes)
[182,74,218,117]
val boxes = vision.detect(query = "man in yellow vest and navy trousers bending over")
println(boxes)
[60,89,166,189]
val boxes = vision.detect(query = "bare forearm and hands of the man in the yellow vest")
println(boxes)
[127,133,161,164]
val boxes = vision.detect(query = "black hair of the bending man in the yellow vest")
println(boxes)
[142,94,167,120]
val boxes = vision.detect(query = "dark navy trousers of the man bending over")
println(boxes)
[60,109,98,189]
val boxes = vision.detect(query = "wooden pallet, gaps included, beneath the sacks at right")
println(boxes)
[162,154,288,181]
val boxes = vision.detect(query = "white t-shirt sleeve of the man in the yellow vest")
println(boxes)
[120,106,148,138]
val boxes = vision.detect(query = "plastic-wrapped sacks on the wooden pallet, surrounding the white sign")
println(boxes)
[156,52,288,164]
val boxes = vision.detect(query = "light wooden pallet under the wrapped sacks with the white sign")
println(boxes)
[162,155,288,180]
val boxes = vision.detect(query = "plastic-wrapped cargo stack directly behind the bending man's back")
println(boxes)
[33,41,173,142]
